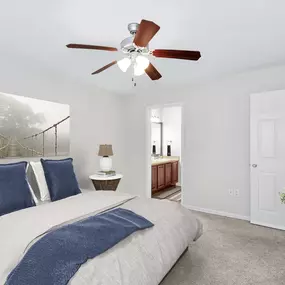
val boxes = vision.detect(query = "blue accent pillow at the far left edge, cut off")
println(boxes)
[0,161,35,216]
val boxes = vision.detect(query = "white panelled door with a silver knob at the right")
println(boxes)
[250,90,285,230]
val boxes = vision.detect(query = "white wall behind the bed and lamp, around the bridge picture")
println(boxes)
[0,58,125,189]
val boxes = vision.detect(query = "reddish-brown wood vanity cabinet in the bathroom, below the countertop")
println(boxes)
[151,161,179,193]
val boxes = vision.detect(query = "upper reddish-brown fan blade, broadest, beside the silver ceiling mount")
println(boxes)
[134,20,160,47]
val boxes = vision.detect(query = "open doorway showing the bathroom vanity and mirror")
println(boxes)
[146,103,184,203]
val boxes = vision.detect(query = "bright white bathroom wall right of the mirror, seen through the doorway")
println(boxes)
[162,106,182,157]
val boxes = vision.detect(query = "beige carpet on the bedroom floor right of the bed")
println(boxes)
[161,212,285,285]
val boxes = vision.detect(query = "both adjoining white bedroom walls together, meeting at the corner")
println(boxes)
[3,53,285,216]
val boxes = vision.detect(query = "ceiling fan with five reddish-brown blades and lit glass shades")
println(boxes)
[67,20,201,81]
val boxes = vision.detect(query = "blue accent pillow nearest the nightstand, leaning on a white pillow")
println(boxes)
[41,158,81,201]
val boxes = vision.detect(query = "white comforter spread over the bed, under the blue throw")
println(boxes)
[0,191,202,285]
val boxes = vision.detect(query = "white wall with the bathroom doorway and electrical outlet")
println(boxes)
[126,63,285,216]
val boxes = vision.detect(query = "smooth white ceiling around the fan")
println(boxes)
[0,0,285,93]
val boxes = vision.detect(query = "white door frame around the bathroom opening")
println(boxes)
[145,102,185,204]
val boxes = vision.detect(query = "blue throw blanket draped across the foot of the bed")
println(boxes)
[5,208,153,285]
